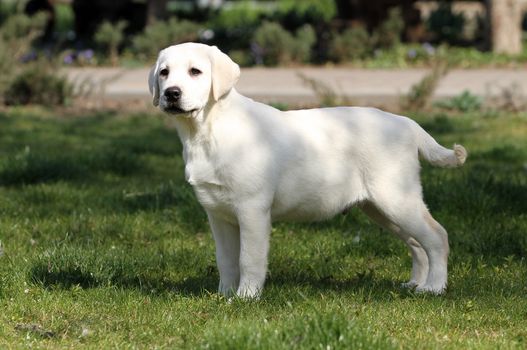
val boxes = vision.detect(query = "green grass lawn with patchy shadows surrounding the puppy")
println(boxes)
[0,109,527,350]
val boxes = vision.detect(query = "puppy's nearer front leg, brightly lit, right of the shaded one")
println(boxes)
[236,208,271,298]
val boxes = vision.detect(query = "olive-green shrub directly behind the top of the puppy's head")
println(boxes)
[132,18,200,60]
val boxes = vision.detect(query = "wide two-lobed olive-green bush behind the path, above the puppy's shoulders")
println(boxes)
[253,22,316,66]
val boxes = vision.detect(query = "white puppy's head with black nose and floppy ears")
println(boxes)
[148,43,240,115]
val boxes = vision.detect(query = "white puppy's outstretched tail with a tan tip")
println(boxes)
[414,123,467,168]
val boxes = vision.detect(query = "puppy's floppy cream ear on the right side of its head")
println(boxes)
[210,46,240,101]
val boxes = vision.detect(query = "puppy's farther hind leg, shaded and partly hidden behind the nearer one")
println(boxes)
[360,202,428,288]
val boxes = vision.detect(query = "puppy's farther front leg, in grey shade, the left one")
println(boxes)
[207,212,240,296]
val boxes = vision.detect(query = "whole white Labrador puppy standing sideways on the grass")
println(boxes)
[148,43,467,297]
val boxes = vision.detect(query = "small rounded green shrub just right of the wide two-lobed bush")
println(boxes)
[328,27,371,62]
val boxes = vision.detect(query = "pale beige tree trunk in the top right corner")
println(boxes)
[486,0,525,55]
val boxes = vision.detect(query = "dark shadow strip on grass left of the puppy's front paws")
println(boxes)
[28,247,218,295]
